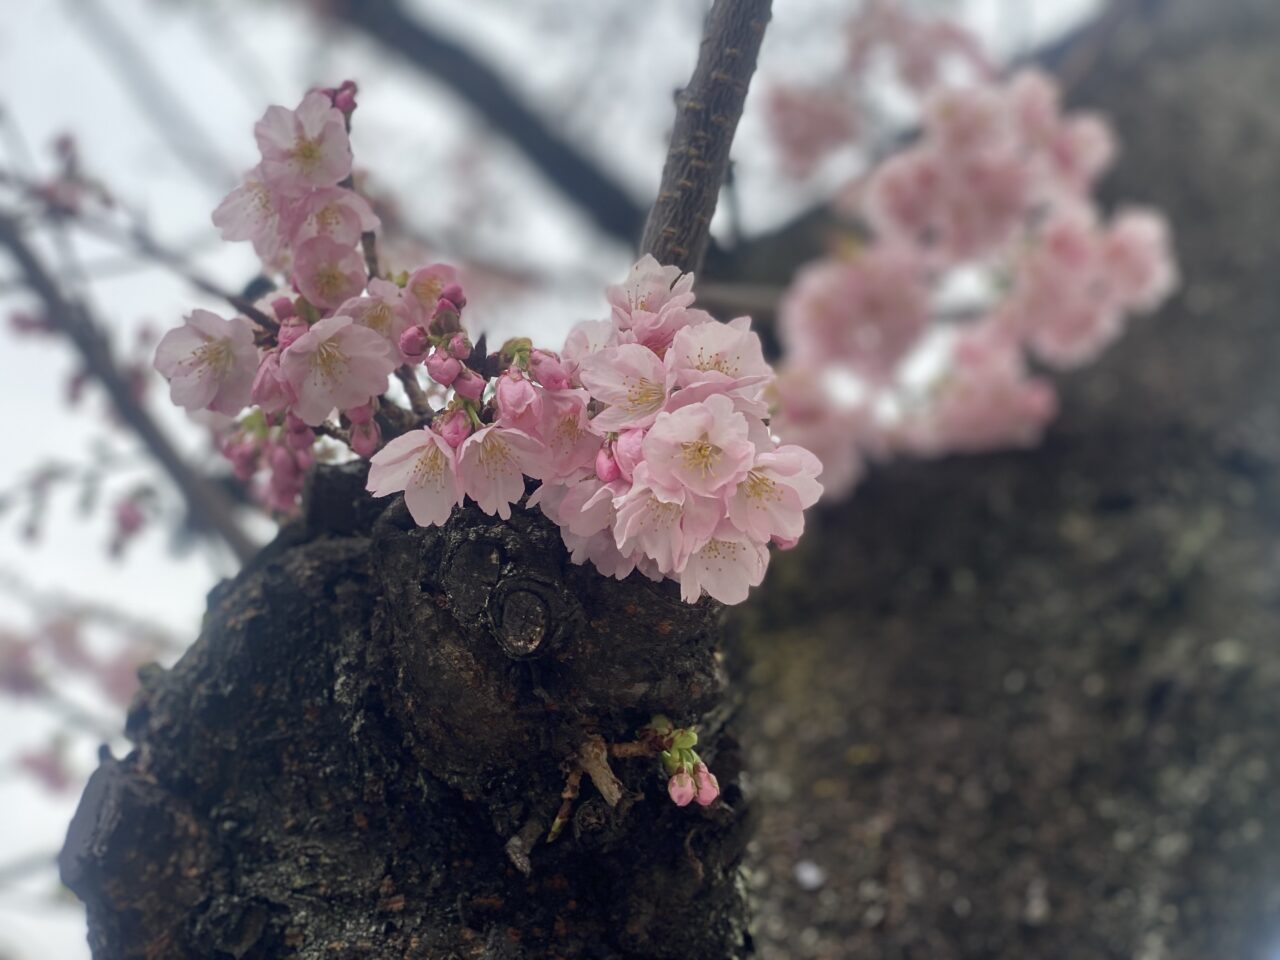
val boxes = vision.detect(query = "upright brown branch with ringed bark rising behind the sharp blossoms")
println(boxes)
[640,0,771,271]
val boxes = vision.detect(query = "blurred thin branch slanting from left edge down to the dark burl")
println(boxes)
[0,214,257,563]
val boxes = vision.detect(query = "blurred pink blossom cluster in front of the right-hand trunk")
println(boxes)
[773,8,1176,497]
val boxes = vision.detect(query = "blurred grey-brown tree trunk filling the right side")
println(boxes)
[744,0,1280,960]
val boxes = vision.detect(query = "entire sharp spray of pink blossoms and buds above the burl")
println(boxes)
[155,84,822,603]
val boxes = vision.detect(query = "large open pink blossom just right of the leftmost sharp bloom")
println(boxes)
[280,316,396,426]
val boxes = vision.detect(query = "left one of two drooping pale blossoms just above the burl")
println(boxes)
[369,429,463,526]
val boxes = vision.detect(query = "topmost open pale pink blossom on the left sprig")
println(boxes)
[253,92,351,196]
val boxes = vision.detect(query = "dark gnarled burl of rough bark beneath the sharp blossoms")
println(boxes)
[61,467,749,960]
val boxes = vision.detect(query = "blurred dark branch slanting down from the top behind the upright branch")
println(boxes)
[330,0,650,243]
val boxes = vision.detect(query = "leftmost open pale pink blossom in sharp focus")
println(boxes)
[155,310,257,416]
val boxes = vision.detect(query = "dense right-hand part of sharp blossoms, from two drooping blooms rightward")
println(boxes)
[369,256,822,603]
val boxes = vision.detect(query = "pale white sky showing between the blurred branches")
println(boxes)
[0,0,1097,960]
